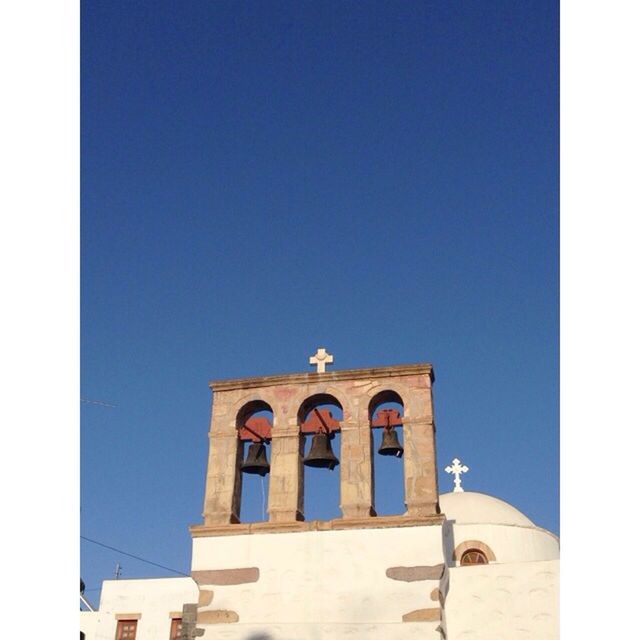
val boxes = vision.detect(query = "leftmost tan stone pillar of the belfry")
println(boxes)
[202,398,242,525]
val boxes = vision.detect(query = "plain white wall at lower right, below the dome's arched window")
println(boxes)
[445,560,559,640]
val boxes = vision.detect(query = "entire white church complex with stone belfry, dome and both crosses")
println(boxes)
[81,349,559,640]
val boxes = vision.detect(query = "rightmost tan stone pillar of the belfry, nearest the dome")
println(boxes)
[403,417,439,516]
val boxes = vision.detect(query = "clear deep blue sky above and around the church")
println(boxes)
[81,0,559,598]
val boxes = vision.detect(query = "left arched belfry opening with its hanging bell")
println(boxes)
[236,400,273,522]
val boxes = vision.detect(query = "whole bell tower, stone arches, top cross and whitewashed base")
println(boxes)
[190,349,445,640]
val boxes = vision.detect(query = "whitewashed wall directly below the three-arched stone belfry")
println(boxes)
[192,525,444,640]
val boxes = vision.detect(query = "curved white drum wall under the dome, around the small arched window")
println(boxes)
[447,524,559,565]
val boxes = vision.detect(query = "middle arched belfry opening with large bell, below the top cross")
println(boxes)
[298,394,343,520]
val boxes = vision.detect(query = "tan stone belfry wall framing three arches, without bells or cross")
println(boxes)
[203,364,438,526]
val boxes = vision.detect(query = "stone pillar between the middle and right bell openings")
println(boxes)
[340,421,375,518]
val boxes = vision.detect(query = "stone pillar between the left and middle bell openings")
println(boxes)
[267,418,304,522]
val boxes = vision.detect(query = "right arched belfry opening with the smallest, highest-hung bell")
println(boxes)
[369,390,406,516]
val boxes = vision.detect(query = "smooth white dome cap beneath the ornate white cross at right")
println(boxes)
[440,491,536,527]
